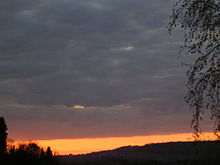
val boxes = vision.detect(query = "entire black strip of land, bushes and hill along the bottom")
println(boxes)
[0,141,220,165]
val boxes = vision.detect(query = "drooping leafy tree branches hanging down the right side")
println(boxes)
[168,0,220,136]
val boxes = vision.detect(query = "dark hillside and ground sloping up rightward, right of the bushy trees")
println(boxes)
[58,141,220,165]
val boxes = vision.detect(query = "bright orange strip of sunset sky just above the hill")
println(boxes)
[27,133,217,154]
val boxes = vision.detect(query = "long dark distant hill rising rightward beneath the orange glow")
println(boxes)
[59,141,220,164]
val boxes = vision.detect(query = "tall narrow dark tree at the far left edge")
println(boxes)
[0,117,8,155]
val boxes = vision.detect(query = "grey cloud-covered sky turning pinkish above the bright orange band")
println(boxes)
[0,0,206,140]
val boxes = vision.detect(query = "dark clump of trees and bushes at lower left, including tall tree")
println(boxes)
[0,117,58,165]
